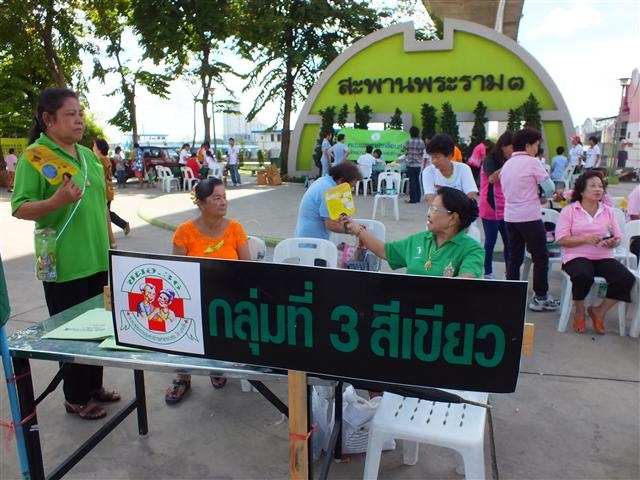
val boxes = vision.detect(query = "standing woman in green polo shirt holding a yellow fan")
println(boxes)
[11,88,120,420]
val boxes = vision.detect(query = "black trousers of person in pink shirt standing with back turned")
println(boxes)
[507,220,549,297]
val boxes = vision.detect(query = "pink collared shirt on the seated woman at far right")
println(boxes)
[556,202,622,263]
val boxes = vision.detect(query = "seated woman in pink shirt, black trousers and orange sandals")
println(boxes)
[556,170,635,335]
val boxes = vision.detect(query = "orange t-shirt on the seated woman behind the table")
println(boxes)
[173,220,248,260]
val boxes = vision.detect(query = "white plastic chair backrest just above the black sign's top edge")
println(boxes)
[273,237,338,268]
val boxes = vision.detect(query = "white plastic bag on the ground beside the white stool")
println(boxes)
[342,385,396,453]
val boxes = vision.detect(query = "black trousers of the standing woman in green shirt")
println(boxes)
[43,272,108,404]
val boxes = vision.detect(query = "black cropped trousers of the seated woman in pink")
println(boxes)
[562,258,636,303]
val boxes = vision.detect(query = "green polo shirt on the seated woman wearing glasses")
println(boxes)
[385,231,484,278]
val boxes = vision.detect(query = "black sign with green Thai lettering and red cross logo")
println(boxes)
[110,251,527,392]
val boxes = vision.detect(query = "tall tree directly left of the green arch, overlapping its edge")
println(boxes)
[236,0,388,173]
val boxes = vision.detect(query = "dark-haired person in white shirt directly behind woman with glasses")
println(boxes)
[422,133,478,205]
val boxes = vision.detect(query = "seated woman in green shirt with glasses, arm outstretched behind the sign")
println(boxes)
[345,187,484,278]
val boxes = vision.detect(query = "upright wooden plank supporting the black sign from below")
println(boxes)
[288,370,309,480]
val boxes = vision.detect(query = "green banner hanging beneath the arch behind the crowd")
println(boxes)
[334,128,411,162]
